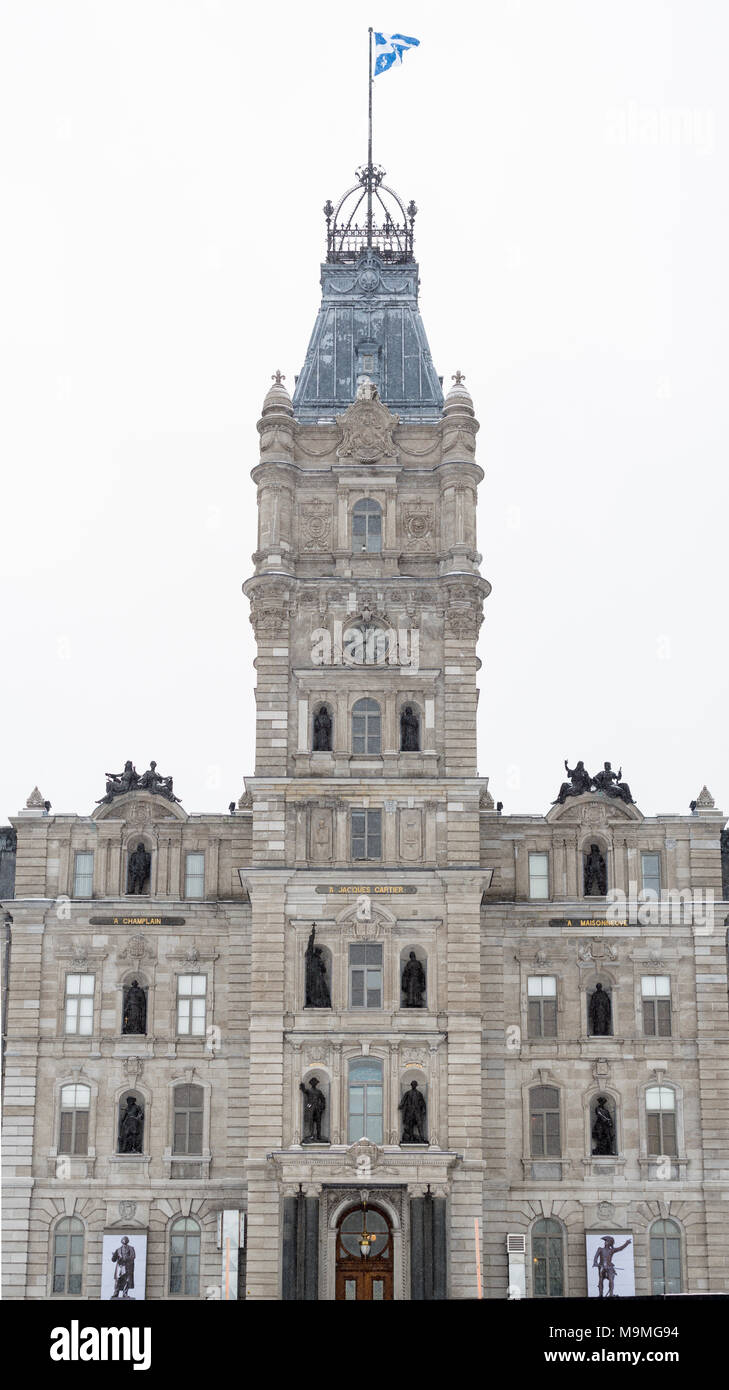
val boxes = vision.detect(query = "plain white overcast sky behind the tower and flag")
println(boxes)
[0,0,729,820]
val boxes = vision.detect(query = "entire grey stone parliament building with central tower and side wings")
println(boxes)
[0,165,729,1301]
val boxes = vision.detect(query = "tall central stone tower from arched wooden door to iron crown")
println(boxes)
[242,167,490,1298]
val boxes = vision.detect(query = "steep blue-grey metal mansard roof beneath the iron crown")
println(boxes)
[294,246,442,424]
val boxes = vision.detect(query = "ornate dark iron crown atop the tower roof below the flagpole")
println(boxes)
[324,164,417,264]
